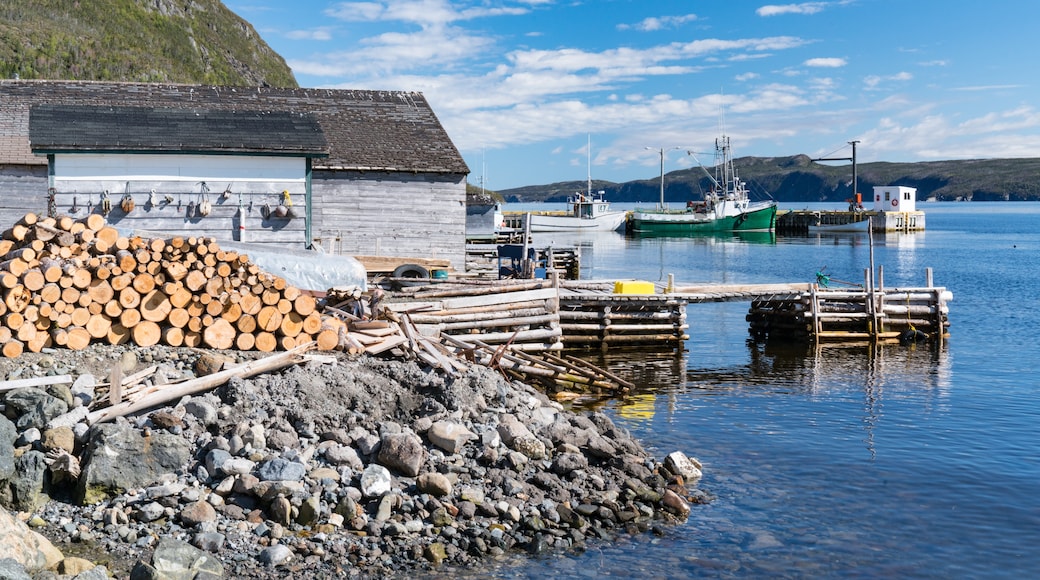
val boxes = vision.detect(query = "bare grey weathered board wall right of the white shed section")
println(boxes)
[311,169,466,271]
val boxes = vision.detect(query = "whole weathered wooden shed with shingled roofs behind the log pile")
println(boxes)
[0,80,469,270]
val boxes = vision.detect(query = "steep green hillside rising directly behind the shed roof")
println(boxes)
[0,0,297,87]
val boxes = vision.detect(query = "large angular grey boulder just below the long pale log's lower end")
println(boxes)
[77,423,191,505]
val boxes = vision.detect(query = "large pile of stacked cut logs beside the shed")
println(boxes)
[0,214,347,358]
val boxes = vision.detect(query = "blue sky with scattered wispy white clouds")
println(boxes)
[231,0,1040,190]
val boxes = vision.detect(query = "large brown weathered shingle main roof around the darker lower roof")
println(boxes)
[0,80,469,174]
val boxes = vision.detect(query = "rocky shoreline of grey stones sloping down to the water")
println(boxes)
[0,345,704,579]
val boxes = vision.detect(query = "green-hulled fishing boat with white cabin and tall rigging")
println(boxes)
[631,135,777,235]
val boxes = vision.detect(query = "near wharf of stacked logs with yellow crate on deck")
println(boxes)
[376,269,953,352]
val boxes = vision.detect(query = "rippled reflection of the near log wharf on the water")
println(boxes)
[571,340,952,460]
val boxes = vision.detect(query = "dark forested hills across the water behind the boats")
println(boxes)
[498,155,1040,204]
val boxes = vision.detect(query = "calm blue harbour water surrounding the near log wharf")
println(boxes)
[484,203,1040,578]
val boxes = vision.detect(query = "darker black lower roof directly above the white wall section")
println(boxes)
[29,105,329,157]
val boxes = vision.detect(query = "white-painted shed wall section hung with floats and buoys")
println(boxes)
[44,154,308,249]
